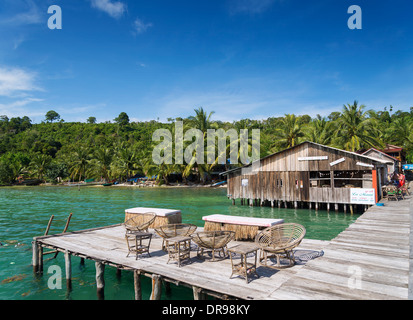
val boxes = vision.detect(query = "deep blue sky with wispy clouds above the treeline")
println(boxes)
[0,0,413,122]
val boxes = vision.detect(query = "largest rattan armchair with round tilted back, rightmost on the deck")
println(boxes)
[255,223,306,269]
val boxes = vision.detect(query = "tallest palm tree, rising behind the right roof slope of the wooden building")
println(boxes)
[337,101,382,151]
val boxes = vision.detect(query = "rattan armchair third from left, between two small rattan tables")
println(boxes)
[192,231,235,261]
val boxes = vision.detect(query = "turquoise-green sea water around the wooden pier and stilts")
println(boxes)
[0,187,358,300]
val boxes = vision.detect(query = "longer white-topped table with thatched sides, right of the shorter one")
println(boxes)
[202,214,284,240]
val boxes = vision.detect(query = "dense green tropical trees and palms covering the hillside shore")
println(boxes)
[0,101,413,185]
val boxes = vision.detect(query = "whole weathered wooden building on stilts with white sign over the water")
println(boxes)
[222,141,387,211]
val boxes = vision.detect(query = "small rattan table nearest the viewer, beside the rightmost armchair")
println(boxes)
[228,244,258,283]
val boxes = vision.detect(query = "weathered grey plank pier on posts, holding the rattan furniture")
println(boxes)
[33,196,411,300]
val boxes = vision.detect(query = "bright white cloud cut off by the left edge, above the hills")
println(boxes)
[0,67,41,97]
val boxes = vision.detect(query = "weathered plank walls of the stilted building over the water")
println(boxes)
[227,143,377,204]
